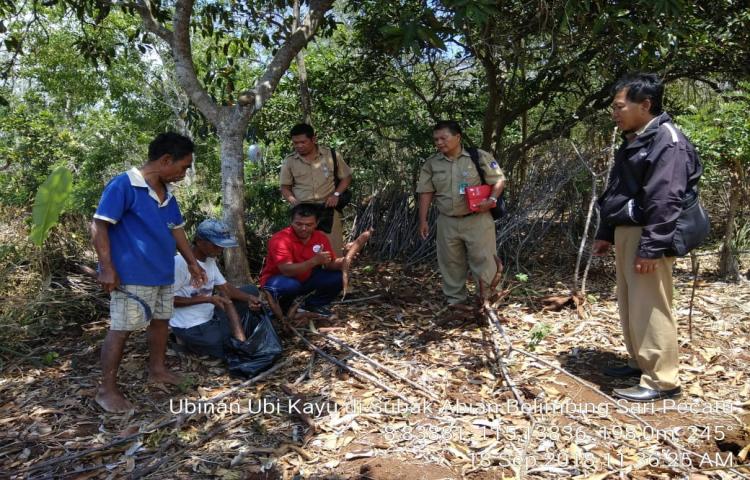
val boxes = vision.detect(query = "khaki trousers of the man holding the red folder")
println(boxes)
[437,213,497,304]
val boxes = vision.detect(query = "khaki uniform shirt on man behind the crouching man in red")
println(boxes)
[280,145,352,203]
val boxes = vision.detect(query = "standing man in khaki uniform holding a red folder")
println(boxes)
[417,120,505,305]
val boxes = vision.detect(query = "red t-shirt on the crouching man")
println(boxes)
[260,227,336,286]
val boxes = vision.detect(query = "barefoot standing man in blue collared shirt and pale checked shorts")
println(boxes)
[91,133,206,413]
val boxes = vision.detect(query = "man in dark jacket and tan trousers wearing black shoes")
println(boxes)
[593,74,702,402]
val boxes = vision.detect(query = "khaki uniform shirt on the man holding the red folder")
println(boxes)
[417,149,505,217]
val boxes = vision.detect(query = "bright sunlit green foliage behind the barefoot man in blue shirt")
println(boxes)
[0,10,197,209]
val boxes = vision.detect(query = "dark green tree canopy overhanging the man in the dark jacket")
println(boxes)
[351,0,750,172]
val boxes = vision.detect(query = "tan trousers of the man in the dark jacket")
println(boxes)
[615,226,680,390]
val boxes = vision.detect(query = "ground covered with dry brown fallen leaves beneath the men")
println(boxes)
[0,253,750,480]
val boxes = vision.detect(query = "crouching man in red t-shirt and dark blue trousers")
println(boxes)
[260,203,346,316]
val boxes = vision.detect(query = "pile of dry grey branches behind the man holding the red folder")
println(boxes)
[352,144,607,271]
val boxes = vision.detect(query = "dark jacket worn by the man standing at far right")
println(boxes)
[596,113,703,258]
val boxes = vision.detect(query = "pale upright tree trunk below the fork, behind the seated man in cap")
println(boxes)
[217,115,250,285]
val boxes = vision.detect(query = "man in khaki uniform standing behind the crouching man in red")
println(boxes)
[280,123,352,256]
